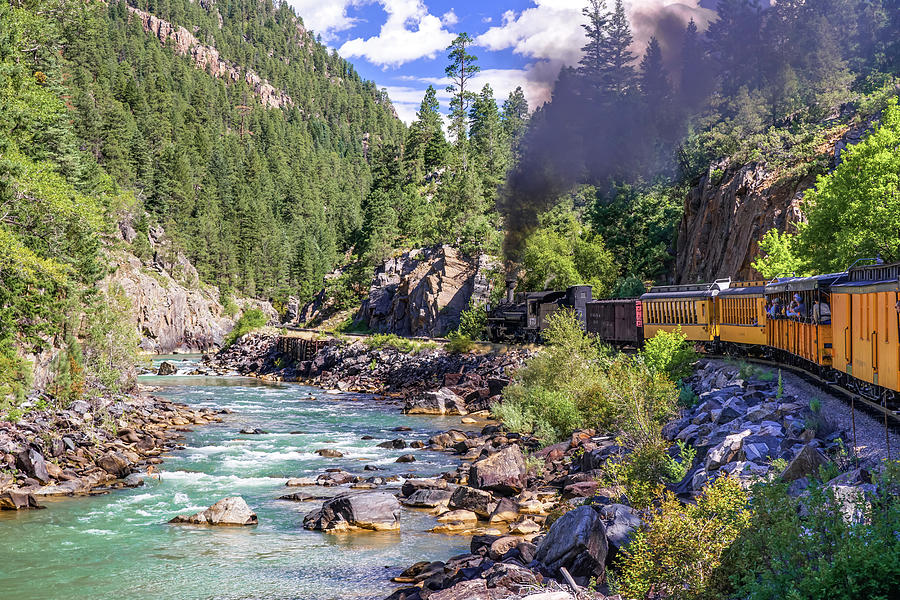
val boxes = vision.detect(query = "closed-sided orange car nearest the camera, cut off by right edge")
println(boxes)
[831,264,900,392]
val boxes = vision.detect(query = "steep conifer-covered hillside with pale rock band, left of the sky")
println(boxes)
[61,0,404,298]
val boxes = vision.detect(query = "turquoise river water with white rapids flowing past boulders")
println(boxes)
[0,356,468,600]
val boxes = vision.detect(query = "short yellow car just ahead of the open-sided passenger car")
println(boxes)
[716,281,769,346]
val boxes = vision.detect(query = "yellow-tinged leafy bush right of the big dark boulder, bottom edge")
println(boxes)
[613,477,752,600]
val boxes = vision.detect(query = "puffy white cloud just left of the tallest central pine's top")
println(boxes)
[339,0,456,68]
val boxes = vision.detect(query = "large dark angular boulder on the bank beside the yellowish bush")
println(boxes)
[535,506,608,580]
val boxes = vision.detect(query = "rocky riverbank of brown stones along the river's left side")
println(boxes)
[0,386,225,510]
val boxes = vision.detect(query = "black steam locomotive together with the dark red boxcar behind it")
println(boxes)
[487,281,644,346]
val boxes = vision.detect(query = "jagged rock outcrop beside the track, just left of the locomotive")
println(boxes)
[357,246,495,337]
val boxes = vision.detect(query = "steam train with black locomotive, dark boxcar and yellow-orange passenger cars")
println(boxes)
[487,263,900,405]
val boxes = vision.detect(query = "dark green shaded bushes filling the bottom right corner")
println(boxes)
[715,462,900,600]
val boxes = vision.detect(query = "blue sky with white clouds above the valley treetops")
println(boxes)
[288,0,711,122]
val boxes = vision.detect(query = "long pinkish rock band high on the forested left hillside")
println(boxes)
[128,6,294,108]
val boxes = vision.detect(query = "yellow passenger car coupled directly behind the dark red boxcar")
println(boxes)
[641,279,730,342]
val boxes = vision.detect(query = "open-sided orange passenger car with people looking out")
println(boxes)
[766,273,843,367]
